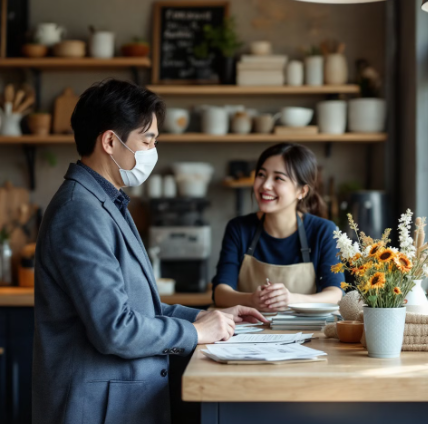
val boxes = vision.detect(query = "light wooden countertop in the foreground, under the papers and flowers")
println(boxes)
[183,330,428,402]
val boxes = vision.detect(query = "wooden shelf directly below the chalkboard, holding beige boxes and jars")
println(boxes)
[147,84,360,96]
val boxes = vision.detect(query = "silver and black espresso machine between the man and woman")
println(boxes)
[149,198,211,293]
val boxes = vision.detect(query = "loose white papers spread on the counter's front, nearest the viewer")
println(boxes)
[202,343,327,363]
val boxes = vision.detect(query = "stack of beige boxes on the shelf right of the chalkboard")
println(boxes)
[236,55,287,86]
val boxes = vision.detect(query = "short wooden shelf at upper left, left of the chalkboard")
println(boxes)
[0,57,151,69]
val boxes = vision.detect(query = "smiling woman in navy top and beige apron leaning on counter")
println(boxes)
[213,143,343,312]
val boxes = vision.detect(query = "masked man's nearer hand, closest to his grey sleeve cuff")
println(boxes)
[193,308,235,344]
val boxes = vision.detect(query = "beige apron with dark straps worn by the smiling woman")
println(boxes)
[238,214,316,294]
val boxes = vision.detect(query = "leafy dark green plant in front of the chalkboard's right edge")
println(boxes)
[195,17,242,84]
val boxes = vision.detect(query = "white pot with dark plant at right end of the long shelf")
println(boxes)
[349,59,386,133]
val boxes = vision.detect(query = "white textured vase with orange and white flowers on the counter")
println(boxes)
[332,209,428,358]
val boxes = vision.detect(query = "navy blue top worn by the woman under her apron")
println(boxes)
[213,213,344,293]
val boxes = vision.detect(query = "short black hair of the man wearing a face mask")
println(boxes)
[71,79,165,156]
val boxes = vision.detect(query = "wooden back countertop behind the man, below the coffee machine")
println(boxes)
[0,286,212,307]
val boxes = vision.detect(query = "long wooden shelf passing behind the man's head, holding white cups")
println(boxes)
[0,133,387,144]
